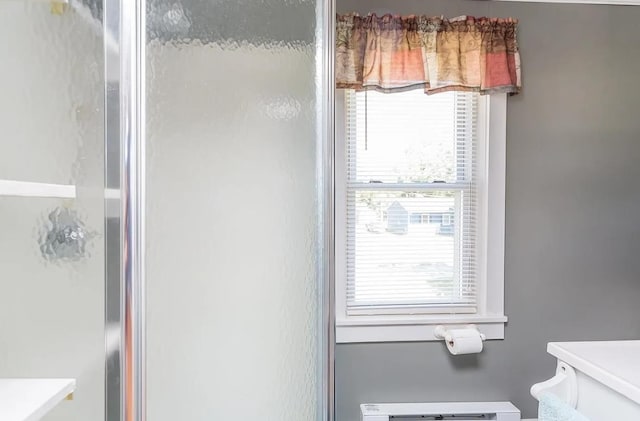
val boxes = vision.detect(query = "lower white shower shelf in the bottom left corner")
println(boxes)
[0,379,76,421]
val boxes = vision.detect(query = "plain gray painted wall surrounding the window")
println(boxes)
[336,0,640,421]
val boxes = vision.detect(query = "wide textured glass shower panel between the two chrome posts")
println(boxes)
[146,0,320,421]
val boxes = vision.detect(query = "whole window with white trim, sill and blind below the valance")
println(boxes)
[336,90,506,342]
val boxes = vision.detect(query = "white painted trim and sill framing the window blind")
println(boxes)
[335,90,507,343]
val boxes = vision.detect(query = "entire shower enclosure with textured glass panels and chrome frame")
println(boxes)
[0,0,333,421]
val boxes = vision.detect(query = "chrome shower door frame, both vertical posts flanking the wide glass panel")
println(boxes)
[103,0,335,421]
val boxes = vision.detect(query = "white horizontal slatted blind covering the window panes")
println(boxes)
[343,90,479,315]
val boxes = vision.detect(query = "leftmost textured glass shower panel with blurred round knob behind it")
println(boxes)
[0,1,104,421]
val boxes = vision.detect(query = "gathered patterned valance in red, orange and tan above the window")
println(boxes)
[336,14,521,94]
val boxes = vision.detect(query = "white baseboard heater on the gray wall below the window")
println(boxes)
[360,402,520,421]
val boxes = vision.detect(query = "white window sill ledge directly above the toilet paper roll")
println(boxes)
[336,314,507,344]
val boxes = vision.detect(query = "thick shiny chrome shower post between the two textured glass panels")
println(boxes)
[103,0,146,421]
